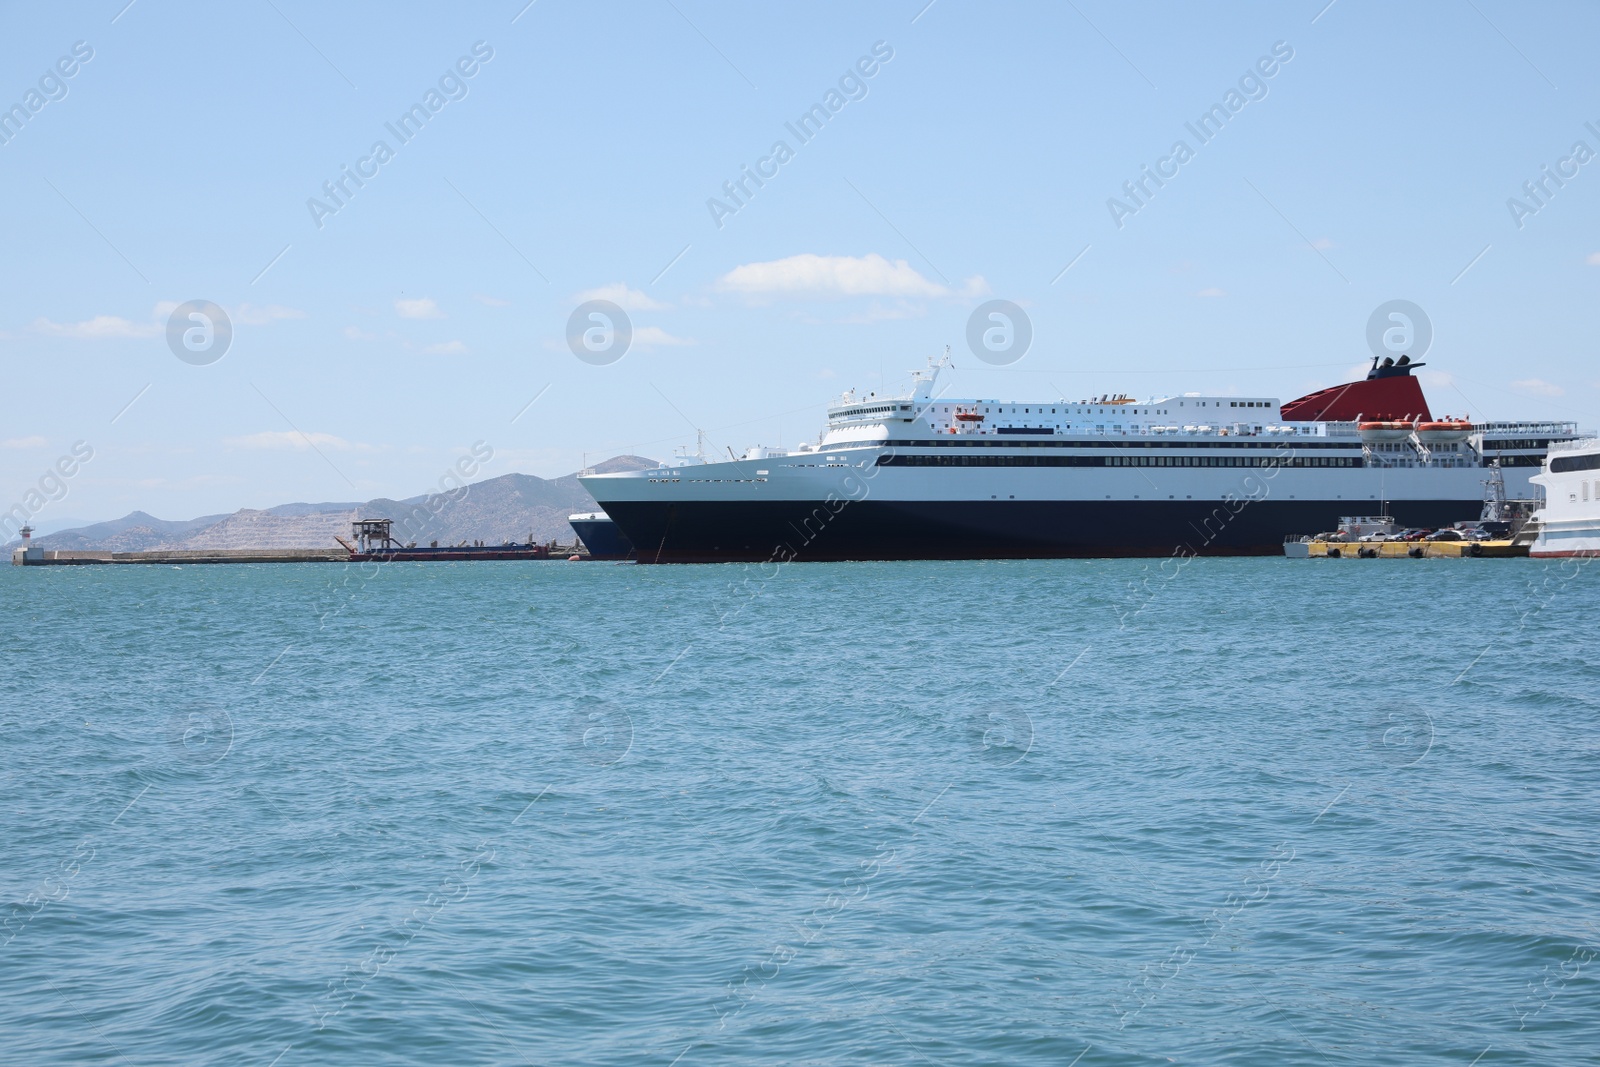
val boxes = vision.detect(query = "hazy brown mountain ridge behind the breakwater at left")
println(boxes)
[8,456,656,552]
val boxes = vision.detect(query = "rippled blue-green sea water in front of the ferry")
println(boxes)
[0,560,1600,1067]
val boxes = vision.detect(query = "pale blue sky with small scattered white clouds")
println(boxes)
[0,0,1600,530]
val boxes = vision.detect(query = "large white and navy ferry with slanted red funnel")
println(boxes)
[581,354,1578,563]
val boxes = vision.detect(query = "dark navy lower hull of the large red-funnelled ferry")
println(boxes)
[603,499,1482,563]
